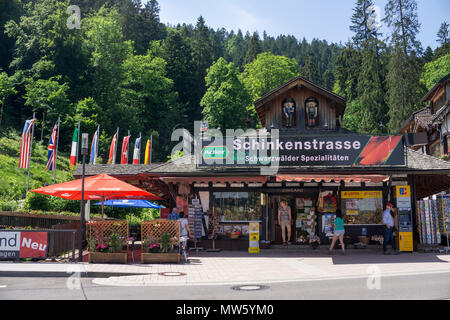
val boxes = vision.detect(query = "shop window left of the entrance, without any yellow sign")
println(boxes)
[214,192,261,221]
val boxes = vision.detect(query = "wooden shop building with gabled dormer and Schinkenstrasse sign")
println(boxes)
[76,77,450,249]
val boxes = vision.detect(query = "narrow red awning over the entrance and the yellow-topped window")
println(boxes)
[277,174,389,183]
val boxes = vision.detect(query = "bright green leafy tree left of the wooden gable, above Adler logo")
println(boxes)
[201,58,251,130]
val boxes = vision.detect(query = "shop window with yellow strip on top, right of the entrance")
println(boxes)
[341,191,383,225]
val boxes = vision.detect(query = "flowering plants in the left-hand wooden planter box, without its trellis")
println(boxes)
[88,233,128,264]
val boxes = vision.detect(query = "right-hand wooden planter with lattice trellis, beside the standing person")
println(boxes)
[141,219,180,264]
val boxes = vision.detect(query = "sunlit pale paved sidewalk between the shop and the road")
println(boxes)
[0,250,450,286]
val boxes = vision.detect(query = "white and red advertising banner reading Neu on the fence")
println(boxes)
[0,231,48,259]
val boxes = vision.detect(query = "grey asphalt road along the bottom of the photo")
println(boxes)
[0,273,450,301]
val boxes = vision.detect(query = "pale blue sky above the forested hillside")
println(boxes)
[158,0,450,49]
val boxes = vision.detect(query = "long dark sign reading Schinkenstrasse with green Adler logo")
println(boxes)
[197,135,406,167]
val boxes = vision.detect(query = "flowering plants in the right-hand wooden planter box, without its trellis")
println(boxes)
[141,233,180,264]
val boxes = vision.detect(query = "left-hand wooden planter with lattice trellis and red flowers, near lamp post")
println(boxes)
[87,220,129,264]
